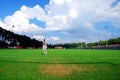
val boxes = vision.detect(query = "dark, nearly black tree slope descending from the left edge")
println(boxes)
[0,27,42,48]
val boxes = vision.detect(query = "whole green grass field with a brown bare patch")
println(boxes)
[0,49,120,80]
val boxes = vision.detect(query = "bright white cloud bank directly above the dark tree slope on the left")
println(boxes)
[0,5,44,37]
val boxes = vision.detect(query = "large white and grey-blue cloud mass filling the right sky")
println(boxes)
[47,0,120,42]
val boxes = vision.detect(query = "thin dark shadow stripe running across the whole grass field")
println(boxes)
[0,60,120,66]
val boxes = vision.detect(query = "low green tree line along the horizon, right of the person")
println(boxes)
[49,38,120,48]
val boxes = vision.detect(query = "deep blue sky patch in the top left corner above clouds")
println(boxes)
[0,0,49,19]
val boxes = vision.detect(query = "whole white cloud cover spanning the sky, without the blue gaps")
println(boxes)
[0,0,120,42]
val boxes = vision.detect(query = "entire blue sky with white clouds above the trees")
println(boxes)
[0,0,120,44]
